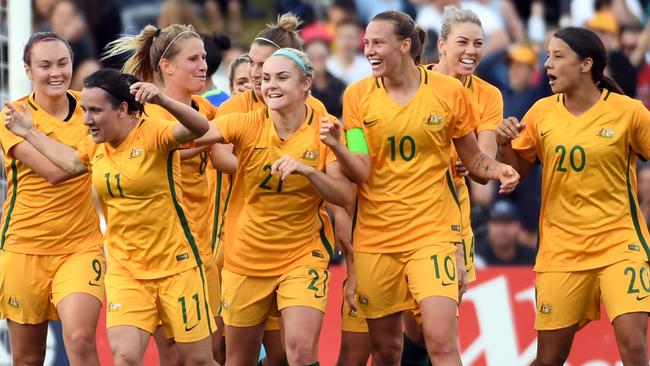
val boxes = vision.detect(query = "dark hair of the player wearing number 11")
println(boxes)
[84,68,144,114]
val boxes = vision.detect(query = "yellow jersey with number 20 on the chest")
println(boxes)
[512,90,650,272]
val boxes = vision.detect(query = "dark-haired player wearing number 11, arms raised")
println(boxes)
[6,69,215,365]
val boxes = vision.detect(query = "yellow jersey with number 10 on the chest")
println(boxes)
[343,67,476,253]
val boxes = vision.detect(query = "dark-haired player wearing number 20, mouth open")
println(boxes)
[497,27,650,366]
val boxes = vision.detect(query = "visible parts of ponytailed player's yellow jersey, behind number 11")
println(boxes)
[144,95,217,258]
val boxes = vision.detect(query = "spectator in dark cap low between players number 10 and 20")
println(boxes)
[476,200,535,266]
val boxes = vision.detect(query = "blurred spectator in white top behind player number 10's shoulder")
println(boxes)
[327,21,372,85]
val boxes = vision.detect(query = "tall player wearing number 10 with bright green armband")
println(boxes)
[332,11,519,365]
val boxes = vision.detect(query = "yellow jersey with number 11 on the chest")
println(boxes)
[77,117,202,279]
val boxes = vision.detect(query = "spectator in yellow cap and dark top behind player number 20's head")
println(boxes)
[587,11,637,98]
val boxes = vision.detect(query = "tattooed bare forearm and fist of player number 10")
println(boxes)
[454,133,519,194]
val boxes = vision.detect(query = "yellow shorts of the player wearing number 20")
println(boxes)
[535,260,650,330]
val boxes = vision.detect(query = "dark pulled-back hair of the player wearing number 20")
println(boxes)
[553,27,623,94]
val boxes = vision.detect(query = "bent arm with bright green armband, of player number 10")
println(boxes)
[320,117,370,184]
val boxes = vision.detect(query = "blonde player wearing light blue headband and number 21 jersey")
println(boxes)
[204,48,353,365]
